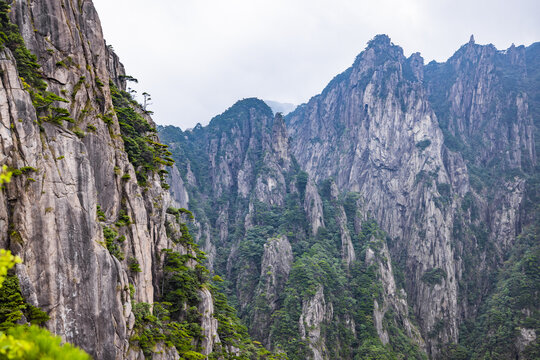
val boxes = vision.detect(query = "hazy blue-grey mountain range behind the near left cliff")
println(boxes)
[159,35,540,359]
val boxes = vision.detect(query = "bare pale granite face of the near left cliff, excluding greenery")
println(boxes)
[0,0,221,359]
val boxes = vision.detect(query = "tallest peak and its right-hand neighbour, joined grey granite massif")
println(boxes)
[287,35,536,356]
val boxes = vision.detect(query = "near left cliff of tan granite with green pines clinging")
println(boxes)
[0,0,273,359]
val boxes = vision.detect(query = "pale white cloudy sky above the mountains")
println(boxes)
[93,0,540,130]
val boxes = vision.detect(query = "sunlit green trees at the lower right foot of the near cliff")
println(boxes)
[131,218,286,360]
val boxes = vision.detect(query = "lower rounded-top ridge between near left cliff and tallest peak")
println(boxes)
[160,99,423,359]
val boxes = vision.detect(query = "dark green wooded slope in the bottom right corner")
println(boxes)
[461,217,540,360]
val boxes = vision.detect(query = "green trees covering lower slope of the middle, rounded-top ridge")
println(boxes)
[264,197,426,360]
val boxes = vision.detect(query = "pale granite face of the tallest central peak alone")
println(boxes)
[288,36,462,352]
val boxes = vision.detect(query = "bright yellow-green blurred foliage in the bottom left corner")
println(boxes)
[0,325,91,360]
